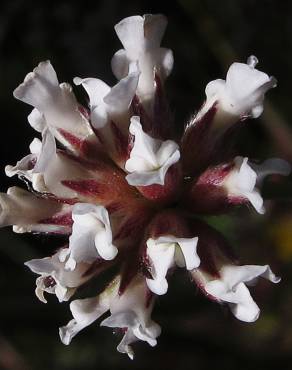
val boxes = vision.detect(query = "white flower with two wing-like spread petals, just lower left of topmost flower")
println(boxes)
[74,71,139,129]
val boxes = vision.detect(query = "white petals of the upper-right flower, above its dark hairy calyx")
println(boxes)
[203,56,277,124]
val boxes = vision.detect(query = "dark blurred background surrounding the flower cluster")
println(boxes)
[0,0,292,370]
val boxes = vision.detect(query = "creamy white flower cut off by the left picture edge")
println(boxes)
[0,187,70,233]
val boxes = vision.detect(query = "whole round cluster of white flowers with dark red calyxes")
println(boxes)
[0,15,290,358]
